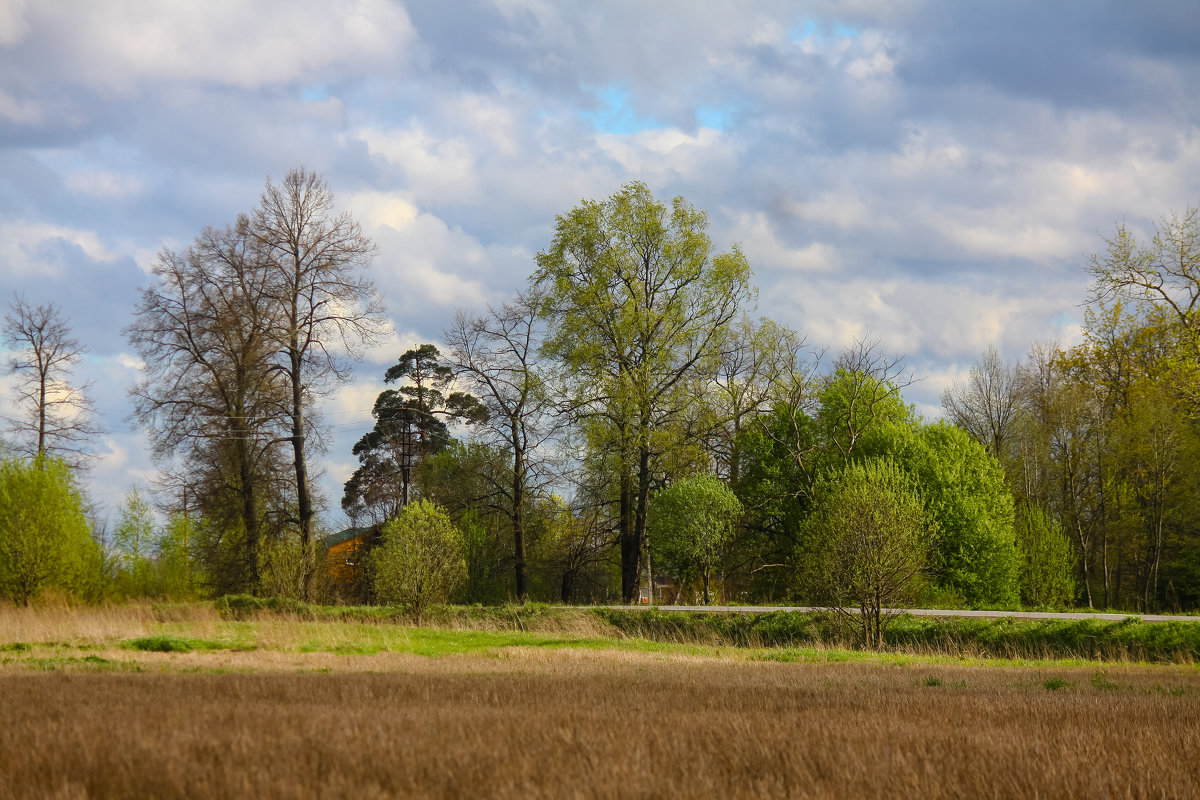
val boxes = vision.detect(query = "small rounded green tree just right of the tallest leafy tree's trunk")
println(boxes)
[650,475,742,606]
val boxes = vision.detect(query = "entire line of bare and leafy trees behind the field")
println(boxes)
[0,170,1200,618]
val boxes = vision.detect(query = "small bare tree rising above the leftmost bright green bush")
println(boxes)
[2,295,104,468]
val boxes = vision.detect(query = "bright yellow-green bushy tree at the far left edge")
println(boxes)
[0,456,101,604]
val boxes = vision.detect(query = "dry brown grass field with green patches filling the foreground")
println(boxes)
[0,606,1200,798]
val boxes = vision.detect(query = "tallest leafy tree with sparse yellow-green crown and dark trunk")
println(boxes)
[534,182,751,602]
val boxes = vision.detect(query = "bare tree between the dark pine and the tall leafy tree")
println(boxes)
[444,293,552,603]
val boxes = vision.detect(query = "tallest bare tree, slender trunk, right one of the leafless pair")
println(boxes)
[247,168,383,594]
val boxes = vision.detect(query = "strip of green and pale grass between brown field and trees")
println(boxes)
[0,597,1200,668]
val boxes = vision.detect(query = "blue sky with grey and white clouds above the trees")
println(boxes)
[0,0,1200,528]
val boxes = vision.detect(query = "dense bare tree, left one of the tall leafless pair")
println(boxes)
[126,224,287,591]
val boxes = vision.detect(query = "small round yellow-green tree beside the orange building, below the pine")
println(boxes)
[371,500,467,618]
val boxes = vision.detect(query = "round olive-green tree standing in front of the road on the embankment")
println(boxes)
[800,459,936,649]
